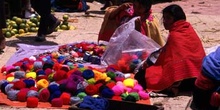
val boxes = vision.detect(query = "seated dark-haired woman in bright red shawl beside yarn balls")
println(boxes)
[135,4,205,95]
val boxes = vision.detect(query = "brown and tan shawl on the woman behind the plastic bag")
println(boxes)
[98,6,164,46]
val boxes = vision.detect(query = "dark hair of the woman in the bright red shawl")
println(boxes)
[162,4,186,21]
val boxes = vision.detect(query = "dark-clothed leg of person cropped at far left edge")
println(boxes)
[0,0,6,53]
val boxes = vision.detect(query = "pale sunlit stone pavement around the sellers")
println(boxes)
[0,0,220,110]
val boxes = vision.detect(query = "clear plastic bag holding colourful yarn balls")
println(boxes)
[101,18,160,73]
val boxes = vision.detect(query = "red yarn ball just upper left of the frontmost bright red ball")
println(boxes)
[17,88,29,102]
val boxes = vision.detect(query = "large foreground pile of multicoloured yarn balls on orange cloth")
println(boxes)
[0,59,149,107]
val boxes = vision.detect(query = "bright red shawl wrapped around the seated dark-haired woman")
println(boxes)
[145,20,205,90]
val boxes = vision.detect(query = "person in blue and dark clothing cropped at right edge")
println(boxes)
[191,47,220,110]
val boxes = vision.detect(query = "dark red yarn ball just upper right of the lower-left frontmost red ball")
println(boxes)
[39,88,50,102]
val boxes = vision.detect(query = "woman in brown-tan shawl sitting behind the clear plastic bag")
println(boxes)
[98,0,164,46]
